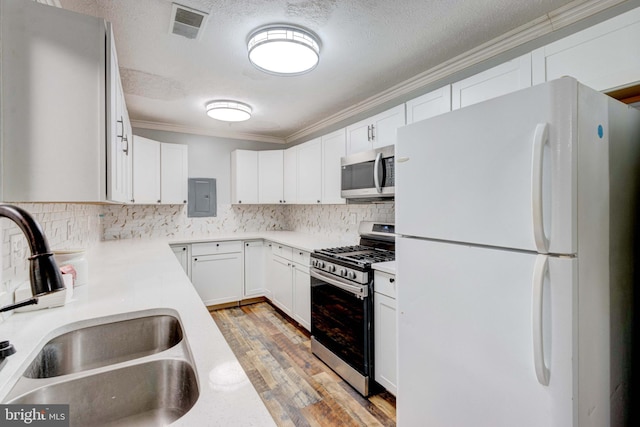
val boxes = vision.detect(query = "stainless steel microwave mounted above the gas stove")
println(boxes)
[341,145,395,202]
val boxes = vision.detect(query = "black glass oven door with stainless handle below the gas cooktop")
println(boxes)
[311,268,373,376]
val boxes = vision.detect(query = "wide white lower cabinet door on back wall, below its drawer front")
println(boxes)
[191,252,243,306]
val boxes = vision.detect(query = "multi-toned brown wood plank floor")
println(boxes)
[211,302,396,427]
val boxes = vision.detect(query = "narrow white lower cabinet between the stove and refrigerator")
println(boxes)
[373,271,398,396]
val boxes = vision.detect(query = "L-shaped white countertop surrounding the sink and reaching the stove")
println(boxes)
[0,231,344,426]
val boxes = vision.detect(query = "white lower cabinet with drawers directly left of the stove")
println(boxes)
[267,243,311,331]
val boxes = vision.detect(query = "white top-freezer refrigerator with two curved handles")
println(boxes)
[395,78,640,427]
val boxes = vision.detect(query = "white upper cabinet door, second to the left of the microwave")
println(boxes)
[297,138,322,204]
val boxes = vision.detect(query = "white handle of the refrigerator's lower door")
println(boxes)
[531,255,550,386]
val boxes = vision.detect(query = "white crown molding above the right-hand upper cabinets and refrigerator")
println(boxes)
[285,0,628,142]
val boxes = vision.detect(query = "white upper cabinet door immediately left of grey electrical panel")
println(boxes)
[160,142,189,204]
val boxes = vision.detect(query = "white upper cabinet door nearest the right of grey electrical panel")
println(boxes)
[231,150,258,204]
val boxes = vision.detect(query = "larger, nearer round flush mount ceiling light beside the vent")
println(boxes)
[247,25,320,76]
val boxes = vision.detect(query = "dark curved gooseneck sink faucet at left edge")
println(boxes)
[0,204,65,312]
